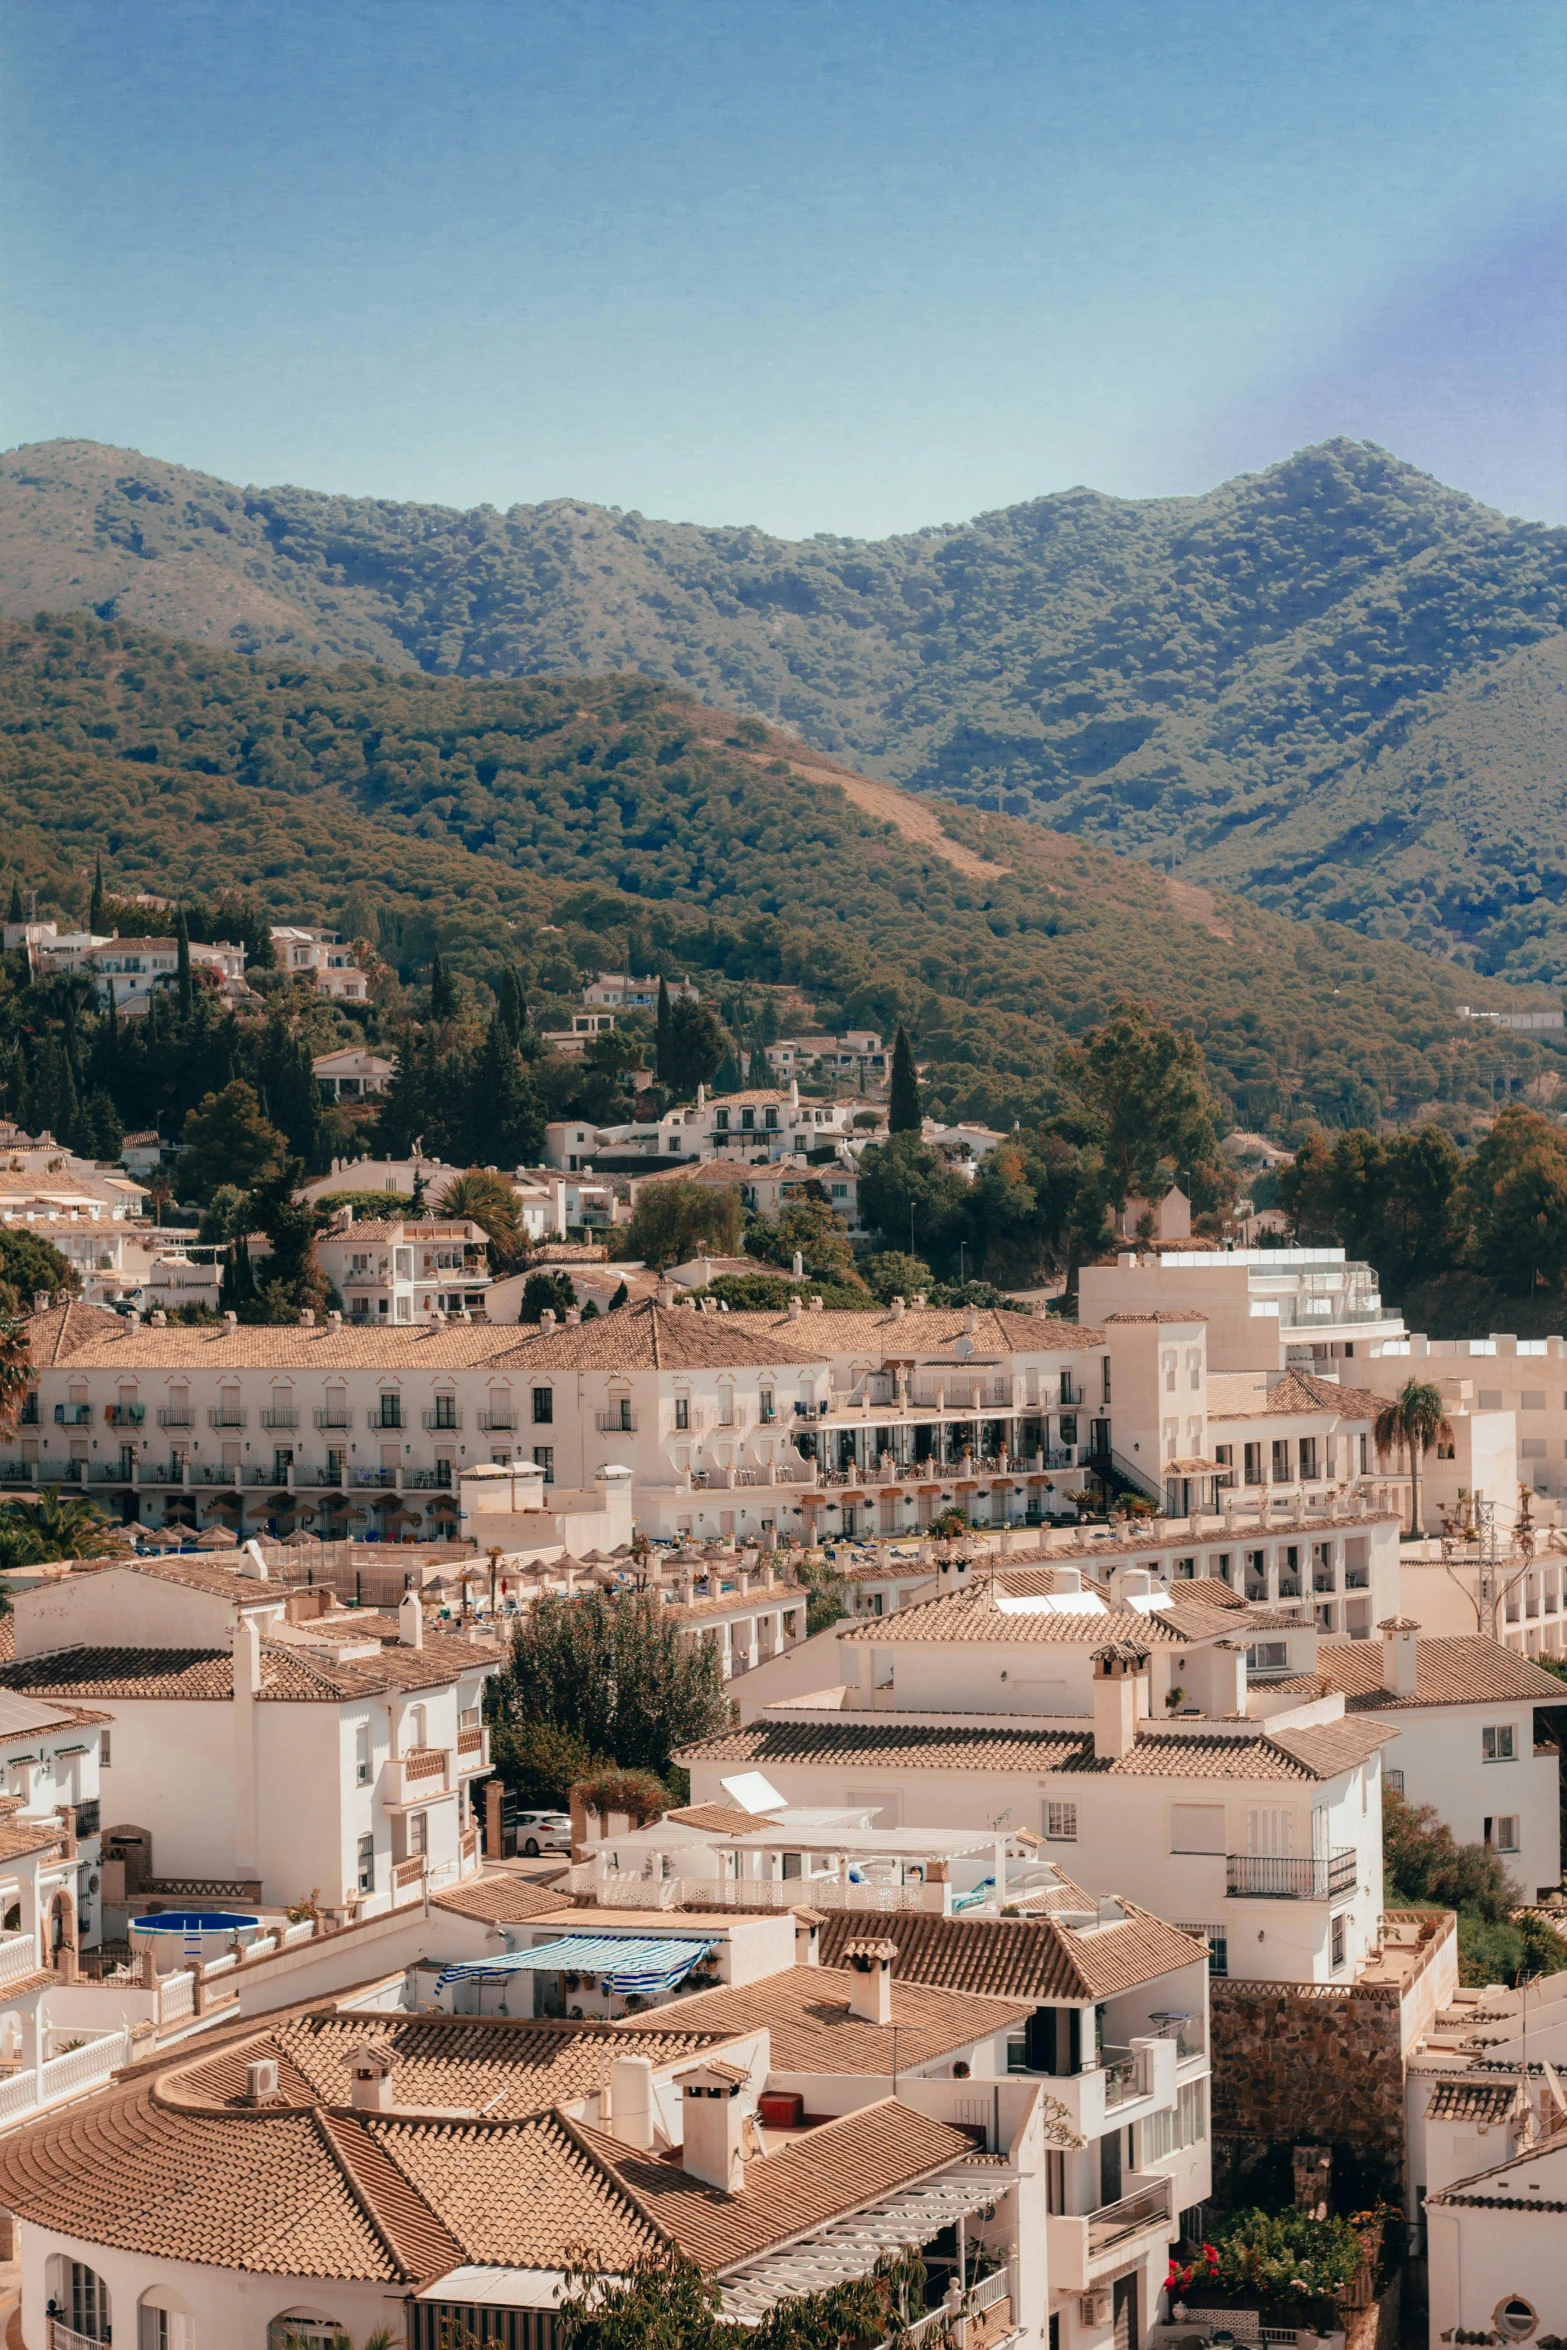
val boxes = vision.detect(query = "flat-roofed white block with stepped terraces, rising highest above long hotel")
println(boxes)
[1078,1248,1405,1377]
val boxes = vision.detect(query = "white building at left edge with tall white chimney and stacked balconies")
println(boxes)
[0,1556,498,1918]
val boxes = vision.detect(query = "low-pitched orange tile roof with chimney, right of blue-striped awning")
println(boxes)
[616,1964,1027,2080]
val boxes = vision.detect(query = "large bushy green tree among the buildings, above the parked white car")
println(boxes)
[491,1591,728,1774]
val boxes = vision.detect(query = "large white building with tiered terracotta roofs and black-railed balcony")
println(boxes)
[679,1565,1398,1983]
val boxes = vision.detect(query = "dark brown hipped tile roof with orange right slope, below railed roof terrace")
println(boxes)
[818,1901,1208,2007]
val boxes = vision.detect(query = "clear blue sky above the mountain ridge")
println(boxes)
[0,0,1567,536]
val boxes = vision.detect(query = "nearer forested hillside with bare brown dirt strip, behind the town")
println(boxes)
[0,613,1560,1130]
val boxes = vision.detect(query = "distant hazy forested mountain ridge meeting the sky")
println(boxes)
[0,442,1567,985]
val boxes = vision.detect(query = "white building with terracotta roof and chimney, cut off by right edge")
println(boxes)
[1316,1617,1565,1901]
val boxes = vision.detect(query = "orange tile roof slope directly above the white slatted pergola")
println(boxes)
[578,2096,973,2272]
